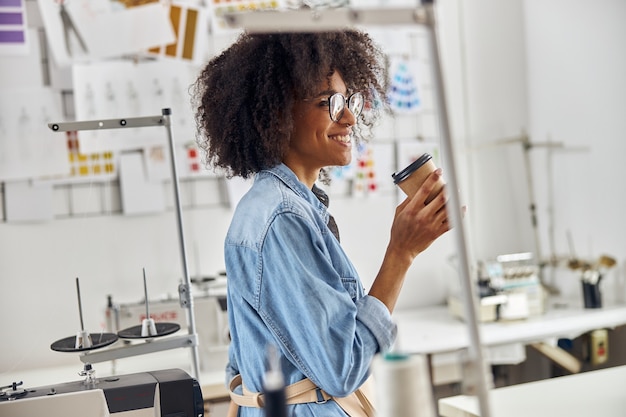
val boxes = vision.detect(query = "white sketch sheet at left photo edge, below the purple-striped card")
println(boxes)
[0,87,69,181]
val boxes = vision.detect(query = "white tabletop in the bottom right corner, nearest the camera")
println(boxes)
[439,366,626,417]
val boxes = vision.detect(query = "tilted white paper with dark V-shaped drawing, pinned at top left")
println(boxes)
[37,0,176,67]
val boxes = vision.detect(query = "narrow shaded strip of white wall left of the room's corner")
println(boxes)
[459,0,533,259]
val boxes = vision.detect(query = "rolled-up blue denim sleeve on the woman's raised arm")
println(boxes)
[257,212,396,396]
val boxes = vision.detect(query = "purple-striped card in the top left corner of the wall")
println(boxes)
[0,0,29,55]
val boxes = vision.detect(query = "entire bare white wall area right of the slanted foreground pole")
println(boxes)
[457,0,626,302]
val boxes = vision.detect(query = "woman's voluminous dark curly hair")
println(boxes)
[192,30,387,178]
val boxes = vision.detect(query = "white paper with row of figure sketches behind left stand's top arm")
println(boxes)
[72,60,196,153]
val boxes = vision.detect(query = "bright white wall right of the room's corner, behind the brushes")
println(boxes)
[524,0,626,302]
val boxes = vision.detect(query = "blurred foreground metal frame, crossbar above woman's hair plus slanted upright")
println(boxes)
[224,0,491,417]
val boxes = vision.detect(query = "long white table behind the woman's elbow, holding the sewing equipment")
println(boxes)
[393,300,626,384]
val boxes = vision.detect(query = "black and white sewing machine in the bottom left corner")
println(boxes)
[0,369,204,417]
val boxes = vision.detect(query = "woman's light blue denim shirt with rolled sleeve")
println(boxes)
[224,164,397,417]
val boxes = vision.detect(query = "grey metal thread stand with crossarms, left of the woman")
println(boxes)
[48,109,200,380]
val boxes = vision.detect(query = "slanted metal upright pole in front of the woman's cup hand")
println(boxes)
[423,2,491,417]
